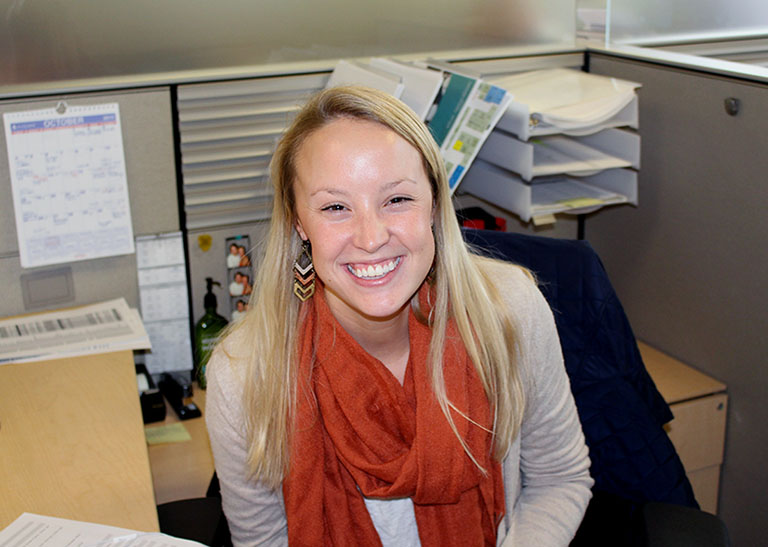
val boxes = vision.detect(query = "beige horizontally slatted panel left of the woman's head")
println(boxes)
[177,74,328,229]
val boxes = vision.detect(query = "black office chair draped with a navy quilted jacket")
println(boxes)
[463,229,730,547]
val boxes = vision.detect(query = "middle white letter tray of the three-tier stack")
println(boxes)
[477,129,640,181]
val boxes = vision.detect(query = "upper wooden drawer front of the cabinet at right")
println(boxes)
[665,393,728,472]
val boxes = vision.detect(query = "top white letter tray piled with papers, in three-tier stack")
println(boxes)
[491,68,640,141]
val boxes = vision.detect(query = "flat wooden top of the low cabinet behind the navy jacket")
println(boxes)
[637,342,726,404]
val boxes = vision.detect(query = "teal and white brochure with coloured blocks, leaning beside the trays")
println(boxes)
[427,68,512,193]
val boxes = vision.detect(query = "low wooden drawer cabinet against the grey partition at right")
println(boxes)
[638,342,728,514]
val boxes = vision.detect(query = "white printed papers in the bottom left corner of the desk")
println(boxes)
[0,513,202,547]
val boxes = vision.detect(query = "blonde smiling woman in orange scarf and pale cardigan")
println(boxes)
[207,87,592,546]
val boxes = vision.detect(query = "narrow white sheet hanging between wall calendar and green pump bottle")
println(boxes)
[136,232,192,374]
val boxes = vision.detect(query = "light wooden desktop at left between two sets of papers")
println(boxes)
[0,351,159,532]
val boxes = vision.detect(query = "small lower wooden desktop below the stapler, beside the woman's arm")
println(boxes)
[147,386,213,505]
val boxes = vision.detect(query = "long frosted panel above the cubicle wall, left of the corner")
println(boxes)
[0,0,575,86]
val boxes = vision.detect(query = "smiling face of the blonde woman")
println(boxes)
[294,118,435,325]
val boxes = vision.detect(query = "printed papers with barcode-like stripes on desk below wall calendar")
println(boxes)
[0,298,151,365]
